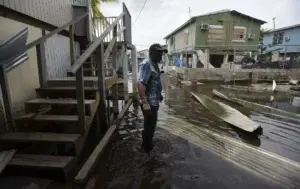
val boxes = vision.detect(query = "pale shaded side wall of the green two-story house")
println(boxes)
[167,23,196,53]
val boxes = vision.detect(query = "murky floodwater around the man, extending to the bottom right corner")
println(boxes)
[94,77,300,189]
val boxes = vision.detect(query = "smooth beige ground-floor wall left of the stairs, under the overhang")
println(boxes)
[0,17,42,112]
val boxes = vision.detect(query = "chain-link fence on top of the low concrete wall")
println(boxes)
[169,45,300,69]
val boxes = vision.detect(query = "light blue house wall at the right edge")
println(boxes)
[263,27,300,53]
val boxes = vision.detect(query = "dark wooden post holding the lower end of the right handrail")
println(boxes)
[76,67,85,135]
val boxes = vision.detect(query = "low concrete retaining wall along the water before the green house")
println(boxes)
[168,66,300,81]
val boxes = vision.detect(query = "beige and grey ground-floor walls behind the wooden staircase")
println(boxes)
[0,17,79,112]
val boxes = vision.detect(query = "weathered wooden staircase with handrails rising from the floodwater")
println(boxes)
[0,2,132,184]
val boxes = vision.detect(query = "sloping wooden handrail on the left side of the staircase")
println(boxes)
[26,12,89,49]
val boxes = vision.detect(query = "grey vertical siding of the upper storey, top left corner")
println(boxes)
[0,0,73,27]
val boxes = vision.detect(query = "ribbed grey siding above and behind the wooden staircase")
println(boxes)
[0,0,86,79]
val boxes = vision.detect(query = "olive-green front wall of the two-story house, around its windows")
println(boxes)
[196,12,261,51]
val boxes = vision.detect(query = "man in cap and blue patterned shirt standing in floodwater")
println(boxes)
[137,43,168,152]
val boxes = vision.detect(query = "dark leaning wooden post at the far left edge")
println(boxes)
[0,65,15,131]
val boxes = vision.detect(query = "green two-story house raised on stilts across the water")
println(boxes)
[165,10,266,67]
